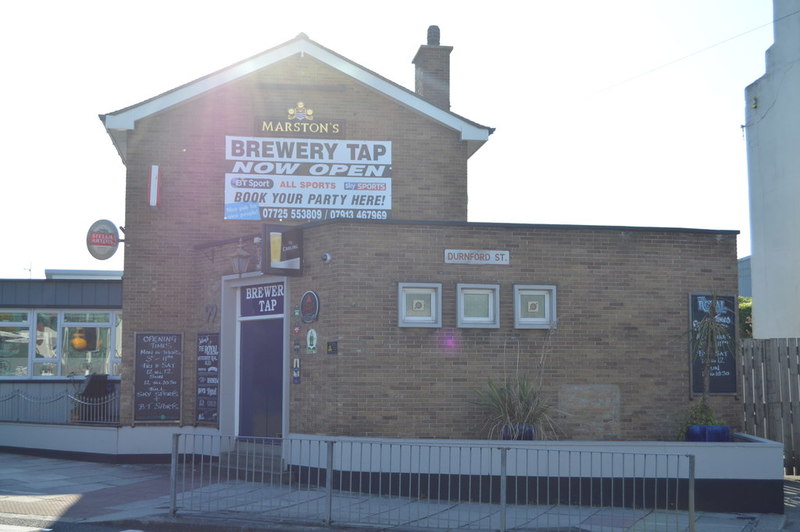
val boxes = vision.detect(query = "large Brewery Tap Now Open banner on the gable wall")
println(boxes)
[225,136,392,221]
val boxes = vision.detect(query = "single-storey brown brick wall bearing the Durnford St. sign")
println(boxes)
[290,223,740,440]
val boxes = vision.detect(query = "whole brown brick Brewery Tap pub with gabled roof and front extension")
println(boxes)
[101,28,740,441]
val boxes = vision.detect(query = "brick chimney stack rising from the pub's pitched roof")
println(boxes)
[411,26,453,111]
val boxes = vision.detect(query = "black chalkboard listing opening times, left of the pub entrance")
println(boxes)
[133,333,183,421]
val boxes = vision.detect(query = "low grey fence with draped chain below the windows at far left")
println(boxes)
[0,389,119,425]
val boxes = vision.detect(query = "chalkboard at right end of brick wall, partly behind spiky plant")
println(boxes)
[689,294,736,394]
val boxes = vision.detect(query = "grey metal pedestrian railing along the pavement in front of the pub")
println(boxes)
[171,434,694,531]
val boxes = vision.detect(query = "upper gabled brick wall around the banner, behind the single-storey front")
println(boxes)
[117,55,467,423]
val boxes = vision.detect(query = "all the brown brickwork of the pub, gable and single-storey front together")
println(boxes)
[115,46,738,439]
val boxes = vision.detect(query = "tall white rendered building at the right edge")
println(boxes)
[745,0,800,338]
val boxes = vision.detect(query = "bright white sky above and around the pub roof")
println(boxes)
[0,0,773,279]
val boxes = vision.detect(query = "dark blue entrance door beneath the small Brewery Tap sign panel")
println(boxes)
[239,319,283,437]
